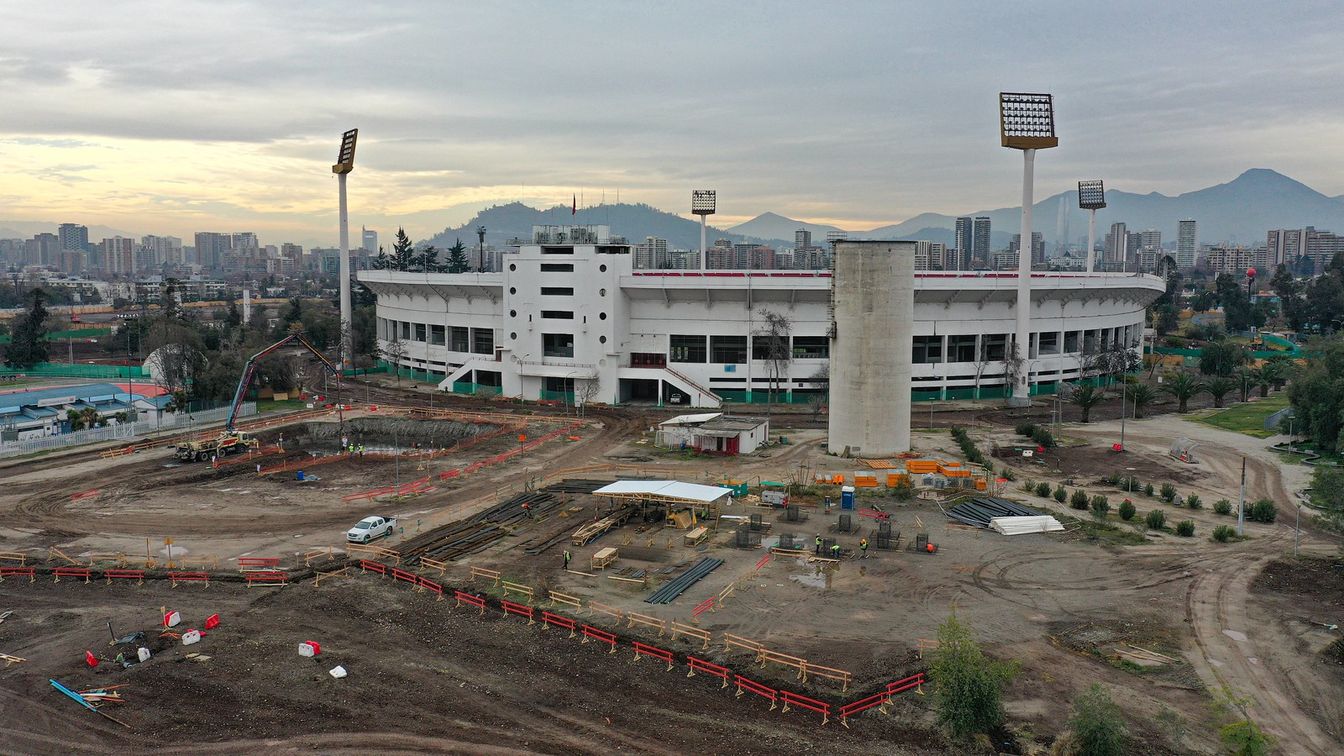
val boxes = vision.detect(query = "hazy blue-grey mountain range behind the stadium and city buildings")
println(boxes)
[429,168,1344,249]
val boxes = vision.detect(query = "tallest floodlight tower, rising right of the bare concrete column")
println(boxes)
[999,91,1059,406]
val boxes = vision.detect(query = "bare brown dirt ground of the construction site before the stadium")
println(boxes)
[0,390,1341,753]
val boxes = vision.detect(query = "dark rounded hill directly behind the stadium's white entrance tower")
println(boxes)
[426,202,758,249]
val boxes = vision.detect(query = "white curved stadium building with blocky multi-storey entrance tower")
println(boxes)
[359,227,1164,408]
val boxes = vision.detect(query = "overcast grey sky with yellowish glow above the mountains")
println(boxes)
[0,0,1344,243]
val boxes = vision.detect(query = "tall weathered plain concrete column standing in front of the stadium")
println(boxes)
[827,241,915,457]
